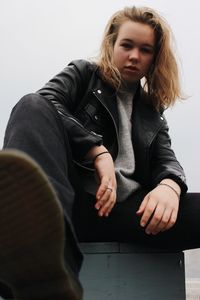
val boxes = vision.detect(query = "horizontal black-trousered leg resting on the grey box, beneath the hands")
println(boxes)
[75,190,200,251]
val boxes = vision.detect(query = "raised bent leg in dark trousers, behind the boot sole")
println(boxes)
[1,94,82,299]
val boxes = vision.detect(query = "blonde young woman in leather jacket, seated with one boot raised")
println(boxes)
[0,7,200,299]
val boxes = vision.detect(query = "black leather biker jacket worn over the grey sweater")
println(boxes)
[38,60,187,193]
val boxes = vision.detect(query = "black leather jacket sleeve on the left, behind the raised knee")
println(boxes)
[37,60,102,160]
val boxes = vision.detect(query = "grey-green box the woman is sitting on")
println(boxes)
[80,243,185,300]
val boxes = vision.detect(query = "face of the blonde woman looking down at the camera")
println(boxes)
[113,21,155,82]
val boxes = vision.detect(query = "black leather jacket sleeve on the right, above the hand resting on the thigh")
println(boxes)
[151,117,187,194]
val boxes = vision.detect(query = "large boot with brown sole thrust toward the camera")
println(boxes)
[0,150,82,300]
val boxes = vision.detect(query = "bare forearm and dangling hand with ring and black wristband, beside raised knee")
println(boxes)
[85,146,117,217]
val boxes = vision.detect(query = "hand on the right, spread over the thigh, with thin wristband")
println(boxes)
[137,179,180,235]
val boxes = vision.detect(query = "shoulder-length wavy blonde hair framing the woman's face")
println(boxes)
[97,6,182,110]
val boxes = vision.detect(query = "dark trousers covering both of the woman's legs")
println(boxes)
[1,94,200,296]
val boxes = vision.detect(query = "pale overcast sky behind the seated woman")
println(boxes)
[0,0,200,191]
